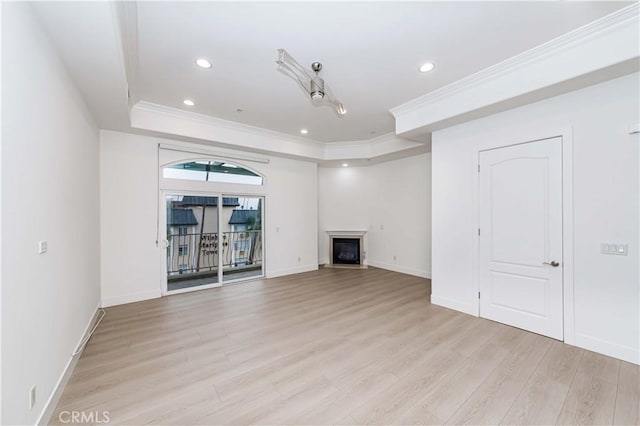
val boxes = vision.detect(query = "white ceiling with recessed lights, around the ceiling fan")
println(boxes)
[36,1,629,142]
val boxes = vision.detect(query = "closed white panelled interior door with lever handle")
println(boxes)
[478,138,563,340]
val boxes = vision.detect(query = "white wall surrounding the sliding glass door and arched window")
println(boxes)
[100,130,318,306]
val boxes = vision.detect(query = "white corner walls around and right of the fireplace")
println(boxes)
[318,154,431,277]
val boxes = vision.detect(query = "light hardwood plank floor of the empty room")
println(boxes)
[52,268,640,425]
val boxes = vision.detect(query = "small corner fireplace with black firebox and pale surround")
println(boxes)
[326,231,367,268]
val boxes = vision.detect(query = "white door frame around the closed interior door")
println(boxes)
[471,126,575,344]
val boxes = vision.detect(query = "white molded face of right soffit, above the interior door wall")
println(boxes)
[390,3,639,134]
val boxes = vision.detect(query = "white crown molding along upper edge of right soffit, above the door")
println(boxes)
[390,3,640,130]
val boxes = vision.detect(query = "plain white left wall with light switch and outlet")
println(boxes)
[2,3,100,424]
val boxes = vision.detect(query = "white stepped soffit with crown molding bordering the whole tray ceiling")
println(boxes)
[116,2,638,165]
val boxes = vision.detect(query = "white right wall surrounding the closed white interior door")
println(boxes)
[432,74,640,363]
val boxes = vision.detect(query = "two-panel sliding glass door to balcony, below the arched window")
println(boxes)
[163,193,264,293]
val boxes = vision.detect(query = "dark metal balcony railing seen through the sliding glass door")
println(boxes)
[167,230,262,276]
